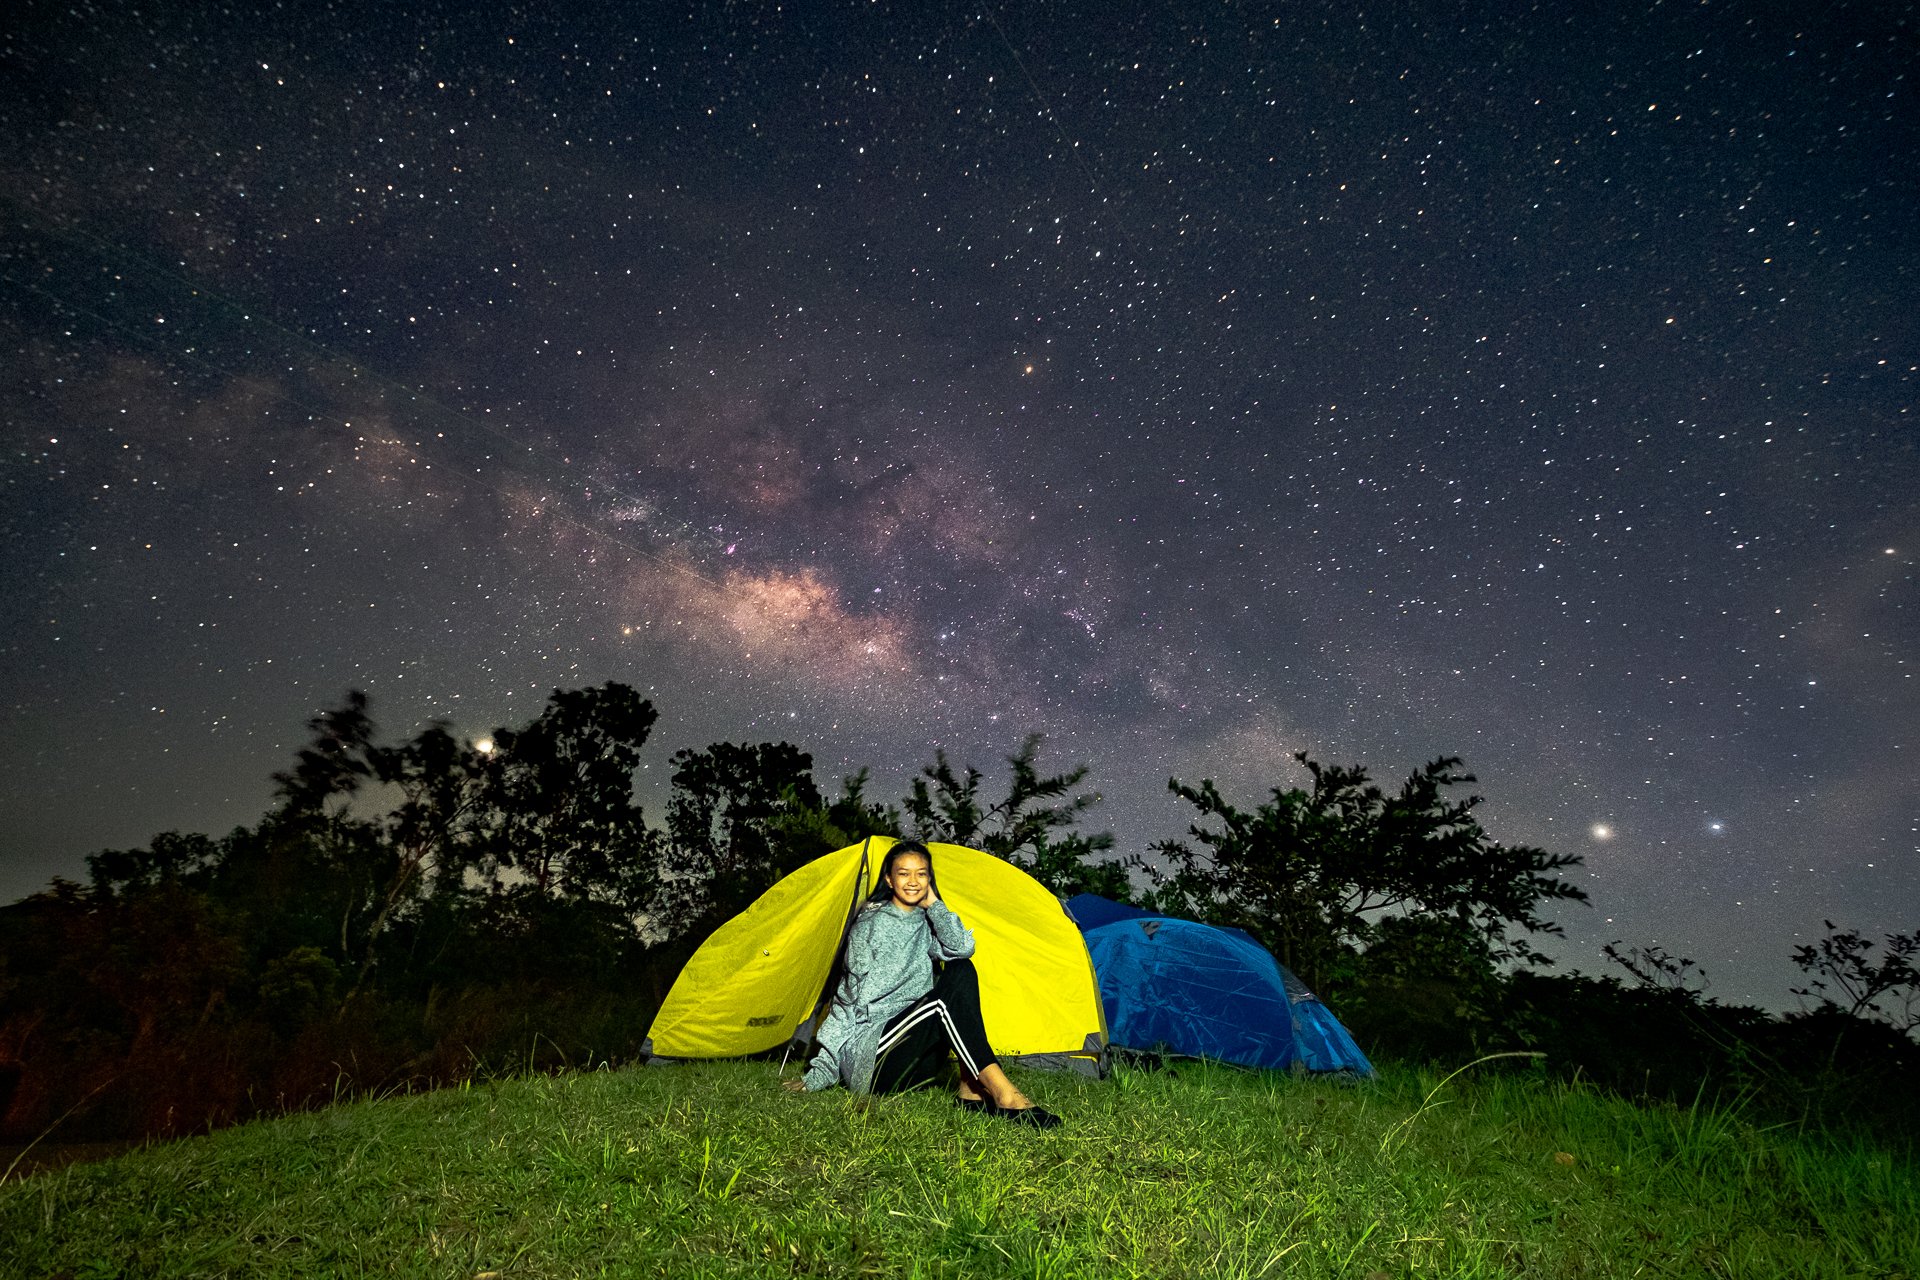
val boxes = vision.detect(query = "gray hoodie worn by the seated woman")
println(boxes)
[806,902,973,1094]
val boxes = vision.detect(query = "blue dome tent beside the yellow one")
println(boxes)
[1068,894,1373,1075]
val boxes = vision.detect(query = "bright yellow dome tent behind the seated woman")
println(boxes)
[647,835,1106,1075]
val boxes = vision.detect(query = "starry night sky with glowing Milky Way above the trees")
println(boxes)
[0,0,1920,1007]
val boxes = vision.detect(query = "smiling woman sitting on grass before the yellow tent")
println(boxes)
[785,841,1060,1128]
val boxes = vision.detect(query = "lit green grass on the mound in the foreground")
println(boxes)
[0,1063,1920,1280]
